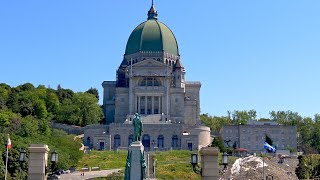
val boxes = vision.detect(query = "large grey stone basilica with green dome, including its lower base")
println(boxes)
[83,4,211,150]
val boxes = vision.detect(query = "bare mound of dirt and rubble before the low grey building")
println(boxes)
[220,156,298,180]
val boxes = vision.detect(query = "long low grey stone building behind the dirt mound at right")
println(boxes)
[220,121,297,153]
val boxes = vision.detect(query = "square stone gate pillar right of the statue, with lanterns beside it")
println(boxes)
[200,147,219,180]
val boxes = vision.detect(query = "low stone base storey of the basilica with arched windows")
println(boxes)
[83,122,211,151]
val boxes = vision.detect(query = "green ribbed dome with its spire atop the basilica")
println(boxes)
[125,4,179,56]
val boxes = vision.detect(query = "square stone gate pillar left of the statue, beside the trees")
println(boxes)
[28,144,49,180]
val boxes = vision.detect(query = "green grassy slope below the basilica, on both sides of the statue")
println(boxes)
[77,150,236,180]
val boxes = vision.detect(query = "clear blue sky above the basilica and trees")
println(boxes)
[0,0,320,117]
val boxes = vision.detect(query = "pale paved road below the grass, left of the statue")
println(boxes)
[60,169,120,180]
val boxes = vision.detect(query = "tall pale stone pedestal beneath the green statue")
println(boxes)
[129,141,144,180]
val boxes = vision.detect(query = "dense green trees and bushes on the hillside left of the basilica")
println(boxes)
[0,83,102,180]
